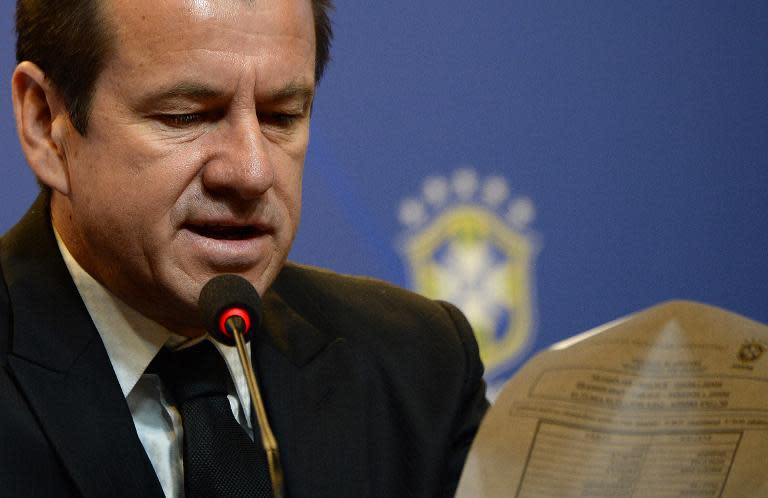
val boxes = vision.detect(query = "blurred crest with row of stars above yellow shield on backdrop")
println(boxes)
[399,169,537,387]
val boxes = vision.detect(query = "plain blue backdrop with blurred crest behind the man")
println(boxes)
[0,0,768,392]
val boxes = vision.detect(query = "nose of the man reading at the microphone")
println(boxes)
[202,112,275,200]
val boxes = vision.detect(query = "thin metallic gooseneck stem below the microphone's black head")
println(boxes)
[226,316,285,498]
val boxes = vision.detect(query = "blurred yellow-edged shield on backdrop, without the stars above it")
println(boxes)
[402,196,534,384]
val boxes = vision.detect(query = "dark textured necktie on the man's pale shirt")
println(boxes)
[150,341,272,498]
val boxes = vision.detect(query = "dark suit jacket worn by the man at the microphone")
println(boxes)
[0,198,487,498]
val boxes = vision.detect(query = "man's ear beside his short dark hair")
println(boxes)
[11,61,74,195]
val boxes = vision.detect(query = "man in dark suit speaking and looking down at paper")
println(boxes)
[0,0,487,497]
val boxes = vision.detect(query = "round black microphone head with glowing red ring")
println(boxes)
[197,274,261,346]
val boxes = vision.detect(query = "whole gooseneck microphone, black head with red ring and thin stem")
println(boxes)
[198,274,285,498]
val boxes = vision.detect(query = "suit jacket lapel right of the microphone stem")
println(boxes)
[253,282,369,497]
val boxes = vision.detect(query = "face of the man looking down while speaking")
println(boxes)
[53,0,315,334]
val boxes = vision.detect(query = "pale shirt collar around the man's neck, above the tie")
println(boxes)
[54,229,255,420]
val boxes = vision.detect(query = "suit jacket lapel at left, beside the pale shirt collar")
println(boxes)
[2,196,162,496]
